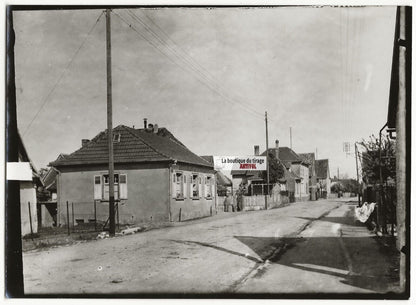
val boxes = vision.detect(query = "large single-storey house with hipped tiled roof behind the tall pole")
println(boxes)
[50,124,216,225]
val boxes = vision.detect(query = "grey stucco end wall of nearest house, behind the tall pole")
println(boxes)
[58,168,169,225]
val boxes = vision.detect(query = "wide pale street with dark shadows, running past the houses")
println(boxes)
[23,200,400,294]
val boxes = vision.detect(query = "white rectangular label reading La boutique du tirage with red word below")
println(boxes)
[214,156,267,171]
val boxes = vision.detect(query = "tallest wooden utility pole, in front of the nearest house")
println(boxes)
[106,9,116,236]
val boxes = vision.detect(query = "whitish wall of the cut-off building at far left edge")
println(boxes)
[20,182,38,236]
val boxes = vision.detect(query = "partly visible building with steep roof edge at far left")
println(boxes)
[18,134,42,236]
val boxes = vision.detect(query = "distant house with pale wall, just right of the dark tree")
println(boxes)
[261,140,309,200]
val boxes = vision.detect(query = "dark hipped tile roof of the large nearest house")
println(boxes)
[50,125,212,167]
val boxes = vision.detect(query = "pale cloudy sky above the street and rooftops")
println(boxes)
[14,6,396,178]
